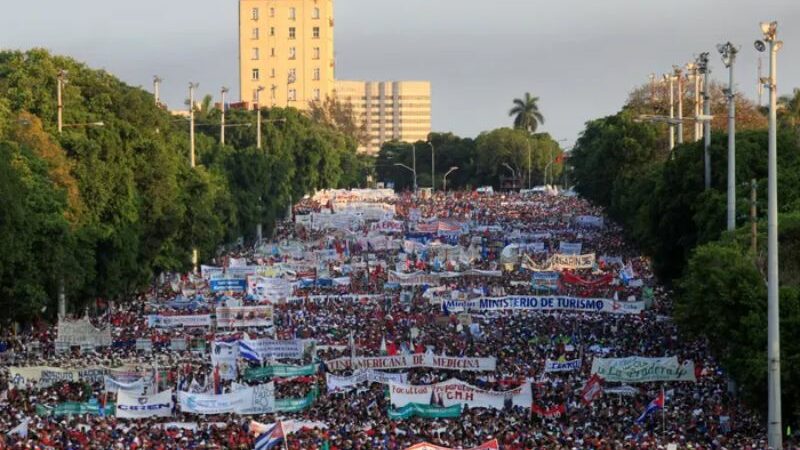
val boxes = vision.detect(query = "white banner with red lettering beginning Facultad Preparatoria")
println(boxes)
[389,378,533,409]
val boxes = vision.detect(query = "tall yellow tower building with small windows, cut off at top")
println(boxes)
[239,0,334,109]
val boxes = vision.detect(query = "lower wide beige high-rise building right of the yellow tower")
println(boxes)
[335,80,431,153]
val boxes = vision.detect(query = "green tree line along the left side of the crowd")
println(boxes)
[0,49,370,325]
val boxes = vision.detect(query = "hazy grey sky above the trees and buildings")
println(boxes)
[0,0,800,142]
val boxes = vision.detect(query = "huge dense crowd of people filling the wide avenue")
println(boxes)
[0,192,780,450]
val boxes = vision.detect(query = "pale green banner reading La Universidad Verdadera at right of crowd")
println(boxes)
[592,356,697,383]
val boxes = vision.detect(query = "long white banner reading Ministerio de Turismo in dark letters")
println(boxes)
[442,295,644,314]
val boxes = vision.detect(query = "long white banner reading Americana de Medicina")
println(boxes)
[325,354,497,372]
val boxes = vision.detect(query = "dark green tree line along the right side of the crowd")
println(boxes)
[568,82,800,424]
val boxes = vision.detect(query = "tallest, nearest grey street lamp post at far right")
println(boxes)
[755,22,783,450]
